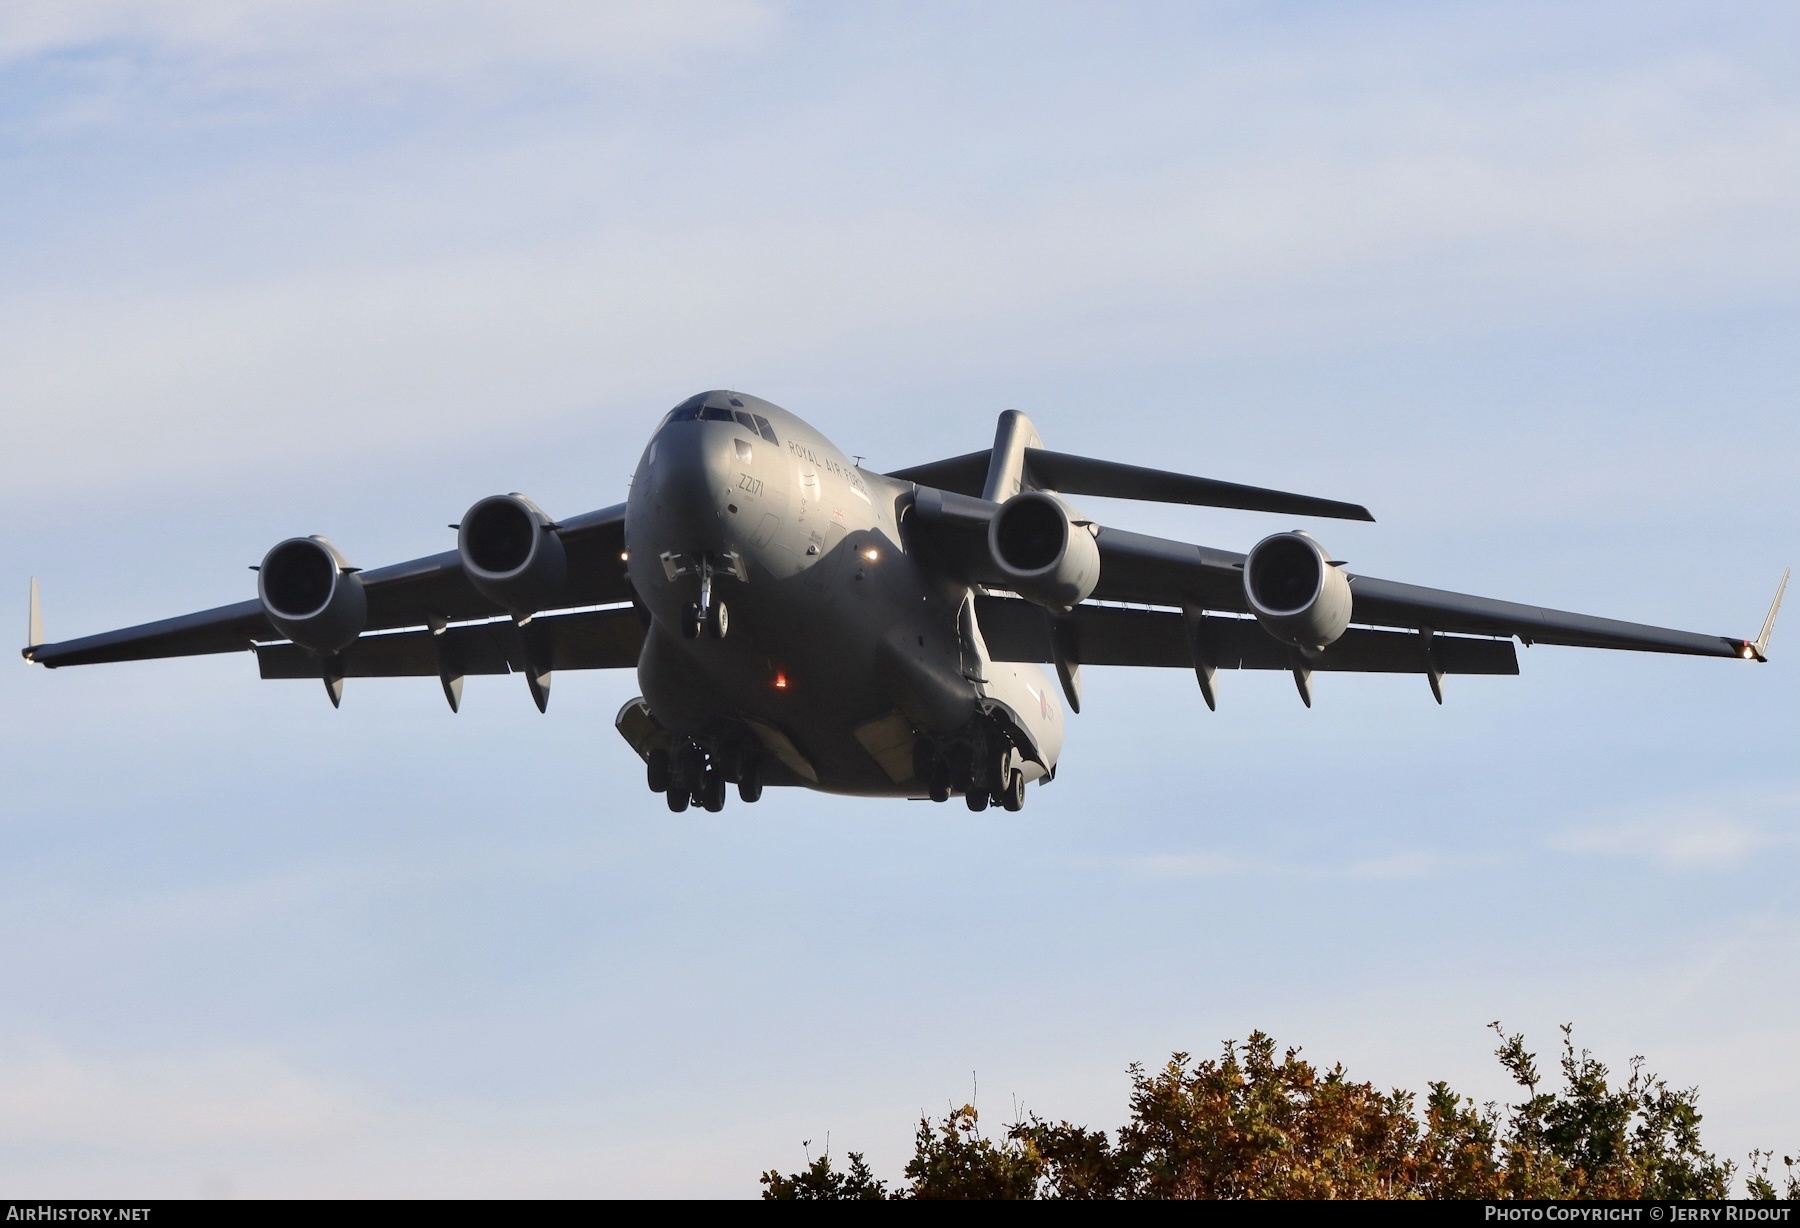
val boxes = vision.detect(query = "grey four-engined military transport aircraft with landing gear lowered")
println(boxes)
[25,391,1787,810]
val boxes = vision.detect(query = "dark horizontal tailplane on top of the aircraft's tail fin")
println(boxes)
[889,448,1375,520]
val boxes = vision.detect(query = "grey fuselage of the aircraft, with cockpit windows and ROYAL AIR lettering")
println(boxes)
[625,391,1062,796]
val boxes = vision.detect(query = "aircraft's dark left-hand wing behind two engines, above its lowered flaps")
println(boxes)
[25,504,635,677]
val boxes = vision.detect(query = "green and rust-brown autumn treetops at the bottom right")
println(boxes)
[761,1023,1800,1199]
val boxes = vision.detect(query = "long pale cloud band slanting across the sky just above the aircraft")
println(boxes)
[0,98,1800,495]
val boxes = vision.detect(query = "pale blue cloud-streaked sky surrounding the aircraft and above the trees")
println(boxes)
[0,0,1800,1196]
